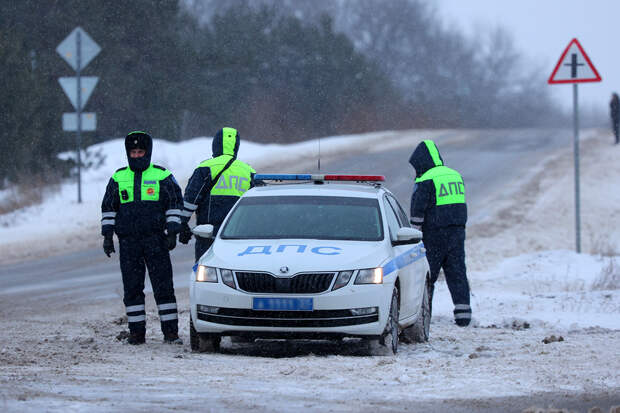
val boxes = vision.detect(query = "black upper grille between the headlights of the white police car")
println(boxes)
[235,271,334,294]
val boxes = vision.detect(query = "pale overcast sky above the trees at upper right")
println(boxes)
[436,0,620,110]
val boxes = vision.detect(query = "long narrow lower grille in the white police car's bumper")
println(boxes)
[198,308,379,327]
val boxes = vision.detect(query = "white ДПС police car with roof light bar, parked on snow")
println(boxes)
[190,174,430,354]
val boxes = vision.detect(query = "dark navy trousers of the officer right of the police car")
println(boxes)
[424,226,471,324]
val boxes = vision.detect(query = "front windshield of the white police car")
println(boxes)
[221,196,383,241]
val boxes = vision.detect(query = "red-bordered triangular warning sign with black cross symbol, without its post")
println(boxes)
[548,39,602,83]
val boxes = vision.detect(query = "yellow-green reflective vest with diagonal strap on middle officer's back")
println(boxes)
[198,155,256,196]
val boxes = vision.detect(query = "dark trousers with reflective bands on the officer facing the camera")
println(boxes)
[119,233,178,336]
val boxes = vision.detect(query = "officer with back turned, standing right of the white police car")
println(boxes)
[409,140,471,327]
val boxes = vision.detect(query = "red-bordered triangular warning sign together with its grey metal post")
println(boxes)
[548,39,602,253]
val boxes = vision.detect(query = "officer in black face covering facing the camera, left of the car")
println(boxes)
[101,131,183,344]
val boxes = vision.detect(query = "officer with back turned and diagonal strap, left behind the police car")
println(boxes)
[179,128,256,262]
